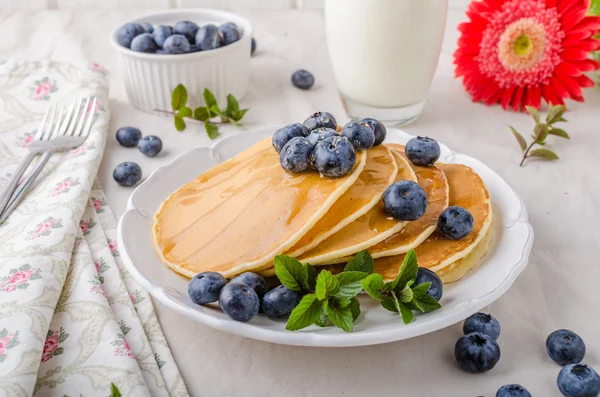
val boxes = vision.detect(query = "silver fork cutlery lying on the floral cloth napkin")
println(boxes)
[0,97,97,224]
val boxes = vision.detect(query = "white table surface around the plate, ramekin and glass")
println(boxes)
[0,6,600,397]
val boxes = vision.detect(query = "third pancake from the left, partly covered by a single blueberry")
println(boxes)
[298,151,417,265]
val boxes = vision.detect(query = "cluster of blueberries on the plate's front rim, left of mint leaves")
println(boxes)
[188,272,301,322]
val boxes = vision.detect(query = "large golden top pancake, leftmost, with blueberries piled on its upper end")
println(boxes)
[152,138,367,277]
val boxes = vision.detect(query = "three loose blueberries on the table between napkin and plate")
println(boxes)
[113,127,162,186]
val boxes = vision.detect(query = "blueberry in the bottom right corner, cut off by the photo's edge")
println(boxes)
[556,364,600,397]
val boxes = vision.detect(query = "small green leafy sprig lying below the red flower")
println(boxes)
[509,105,571,167]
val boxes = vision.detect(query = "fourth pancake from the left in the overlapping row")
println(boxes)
[340,144,449,262]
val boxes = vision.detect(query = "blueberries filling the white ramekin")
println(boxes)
[117,21,244,54]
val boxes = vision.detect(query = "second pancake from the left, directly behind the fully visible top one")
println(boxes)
[285,146,398,257]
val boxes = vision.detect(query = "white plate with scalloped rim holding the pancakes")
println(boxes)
[118,128,533,346]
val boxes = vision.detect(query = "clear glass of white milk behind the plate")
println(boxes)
[325,0,448,125]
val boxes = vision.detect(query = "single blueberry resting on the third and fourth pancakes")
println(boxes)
[383,180,427,221]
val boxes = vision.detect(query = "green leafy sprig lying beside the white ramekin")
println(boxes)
[154,84,249,139]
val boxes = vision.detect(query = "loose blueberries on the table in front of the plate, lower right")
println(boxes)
[454,313,600,397]
